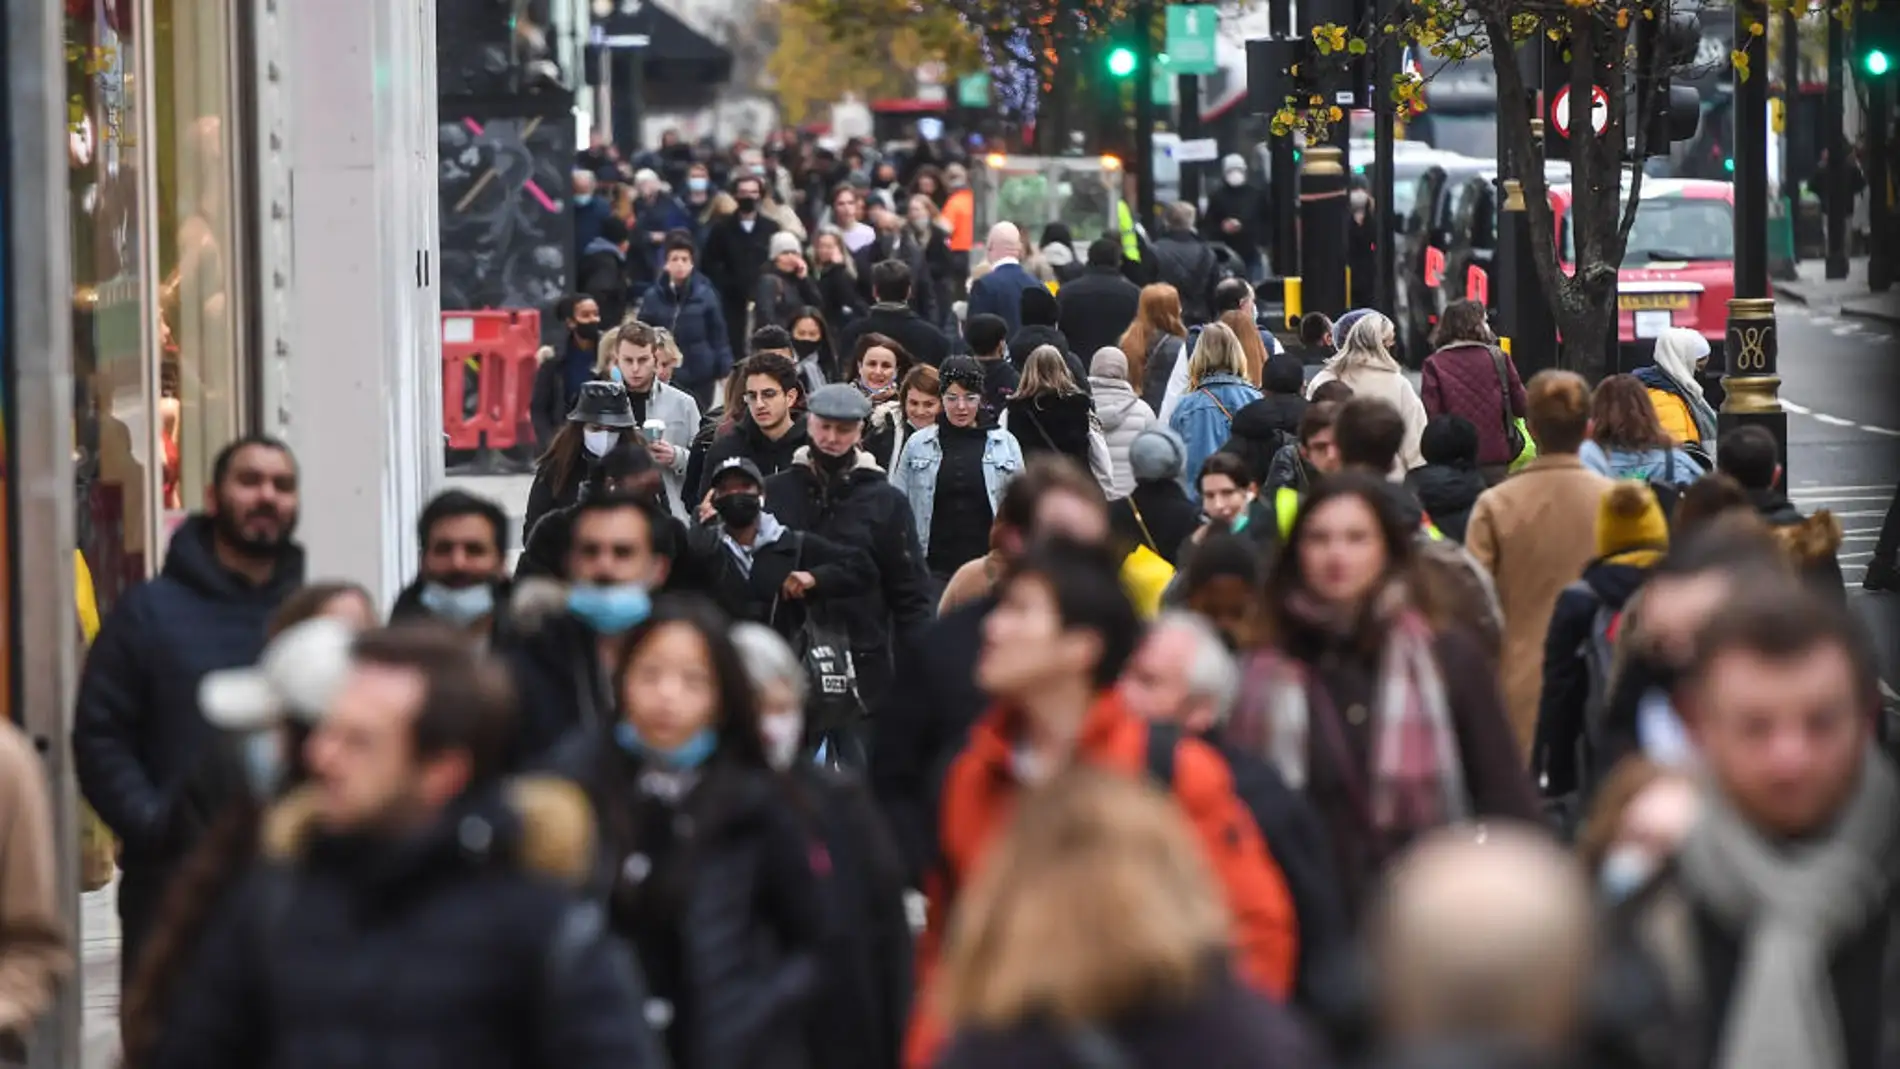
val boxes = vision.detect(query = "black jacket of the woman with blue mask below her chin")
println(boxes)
[557,737,832,1069]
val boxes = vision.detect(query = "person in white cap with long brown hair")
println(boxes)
[122,603,376,1069]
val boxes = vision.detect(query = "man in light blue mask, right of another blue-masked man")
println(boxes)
[496,494,678,767]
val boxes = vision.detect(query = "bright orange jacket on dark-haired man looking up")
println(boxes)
[904,691,1300,1069]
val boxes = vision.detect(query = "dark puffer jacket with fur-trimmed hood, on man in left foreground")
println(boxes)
[150,780,665,1069]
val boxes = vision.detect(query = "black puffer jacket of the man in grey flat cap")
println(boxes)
[766,448,937,704]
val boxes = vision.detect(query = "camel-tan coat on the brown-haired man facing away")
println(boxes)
[1465,454,1615,761]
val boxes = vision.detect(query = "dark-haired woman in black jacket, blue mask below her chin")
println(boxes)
[572,596,828,1069]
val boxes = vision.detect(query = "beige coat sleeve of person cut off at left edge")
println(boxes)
[0,722,72,1035]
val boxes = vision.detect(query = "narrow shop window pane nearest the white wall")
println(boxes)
[152,0,243,532]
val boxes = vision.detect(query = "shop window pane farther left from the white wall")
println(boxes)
[65,0,158,611]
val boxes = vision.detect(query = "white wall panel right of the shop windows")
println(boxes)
[257,0,441,606]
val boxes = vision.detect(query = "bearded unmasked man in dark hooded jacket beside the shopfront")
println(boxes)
[72,437,304,978]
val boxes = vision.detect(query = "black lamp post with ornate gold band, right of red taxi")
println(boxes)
[1732,0,1788,478]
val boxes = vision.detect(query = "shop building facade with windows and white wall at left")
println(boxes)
[0,0,443,1065]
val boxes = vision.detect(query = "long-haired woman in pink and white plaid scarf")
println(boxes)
[1227,473,1541,917]
